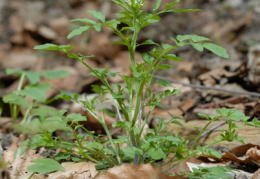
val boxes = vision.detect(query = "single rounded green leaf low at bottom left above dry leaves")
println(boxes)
[27,159,65,174]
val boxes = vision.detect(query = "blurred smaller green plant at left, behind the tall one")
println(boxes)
[3,69,69,124]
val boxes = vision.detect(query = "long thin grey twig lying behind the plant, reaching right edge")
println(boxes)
[155,75,260,97]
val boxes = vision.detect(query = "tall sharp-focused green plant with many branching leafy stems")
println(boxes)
[5,0,256,177]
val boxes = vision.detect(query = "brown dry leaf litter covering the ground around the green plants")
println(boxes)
[0,0,260,179]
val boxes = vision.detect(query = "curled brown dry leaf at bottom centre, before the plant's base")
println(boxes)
[96,164,175,179]
